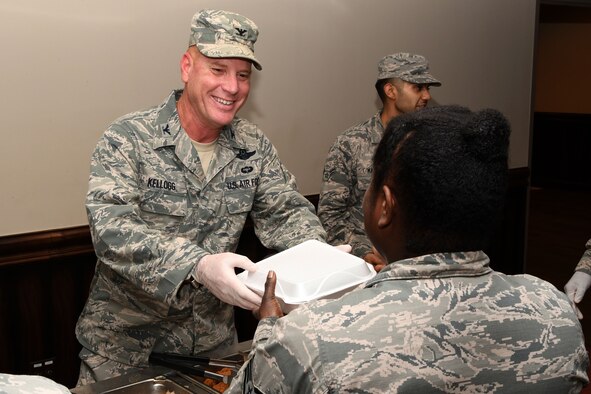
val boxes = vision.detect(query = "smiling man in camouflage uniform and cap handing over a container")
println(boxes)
[76,10,325,385]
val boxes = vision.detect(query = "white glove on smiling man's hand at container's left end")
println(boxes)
[195,253,261,310]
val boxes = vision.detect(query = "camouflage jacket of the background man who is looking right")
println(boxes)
[318,111,384,257]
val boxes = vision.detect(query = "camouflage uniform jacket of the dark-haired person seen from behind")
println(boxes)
[227,252,589,393]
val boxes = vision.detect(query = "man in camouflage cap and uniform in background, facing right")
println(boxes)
[318,53,441,270]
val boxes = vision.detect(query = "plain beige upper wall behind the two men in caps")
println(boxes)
[0,0,536,235]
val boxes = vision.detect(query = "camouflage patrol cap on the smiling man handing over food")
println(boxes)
[189,10,263,70]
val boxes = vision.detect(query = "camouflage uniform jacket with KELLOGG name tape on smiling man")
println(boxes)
[76,91,326,366]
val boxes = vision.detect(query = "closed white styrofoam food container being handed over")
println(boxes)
[238,240,376,312]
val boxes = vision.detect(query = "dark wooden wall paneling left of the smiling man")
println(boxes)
[0,226,96,387]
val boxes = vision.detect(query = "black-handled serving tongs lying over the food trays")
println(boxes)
[149,353,242,384]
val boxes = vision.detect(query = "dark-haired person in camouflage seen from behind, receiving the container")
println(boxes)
[226,106,589,394]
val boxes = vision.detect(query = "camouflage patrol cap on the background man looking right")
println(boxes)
[378,52,441,86]
